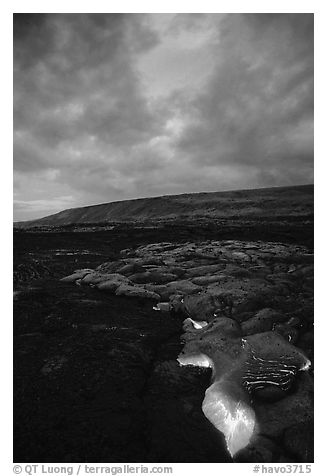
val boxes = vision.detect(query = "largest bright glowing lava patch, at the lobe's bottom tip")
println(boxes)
[202,381,255,456]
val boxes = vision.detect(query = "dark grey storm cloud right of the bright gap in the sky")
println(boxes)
[174,14,313,185]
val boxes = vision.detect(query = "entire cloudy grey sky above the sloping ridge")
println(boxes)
[14,14,313,220]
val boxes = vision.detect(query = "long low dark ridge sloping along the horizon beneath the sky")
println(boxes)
[14,183,314,227]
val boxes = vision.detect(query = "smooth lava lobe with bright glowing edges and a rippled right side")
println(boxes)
[177,318,310,457]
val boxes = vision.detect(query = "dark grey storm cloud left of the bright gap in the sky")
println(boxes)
[14,14,160,170]
